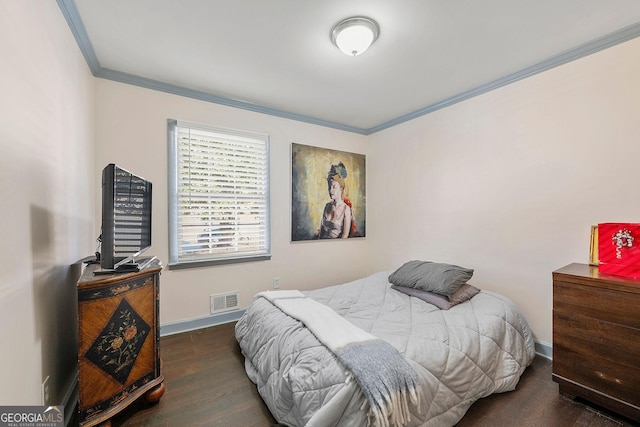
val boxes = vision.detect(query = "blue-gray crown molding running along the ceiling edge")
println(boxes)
[56,0,640,135]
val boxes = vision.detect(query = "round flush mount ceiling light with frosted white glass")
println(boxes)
[331,16,380,56]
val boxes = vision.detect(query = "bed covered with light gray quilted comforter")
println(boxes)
[236,272,535,427]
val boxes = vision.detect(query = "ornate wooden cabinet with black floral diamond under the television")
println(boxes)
[78,261,164,426]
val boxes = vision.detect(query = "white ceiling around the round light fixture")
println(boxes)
[58,0,640,134]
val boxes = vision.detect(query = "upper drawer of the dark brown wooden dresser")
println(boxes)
[553,281,640,330]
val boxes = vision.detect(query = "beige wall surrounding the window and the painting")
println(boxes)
[95,79,372,323]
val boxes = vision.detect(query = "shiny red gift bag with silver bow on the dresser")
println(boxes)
[598,222,640,278]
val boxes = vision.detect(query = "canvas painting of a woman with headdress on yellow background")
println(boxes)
[291,143,366,242]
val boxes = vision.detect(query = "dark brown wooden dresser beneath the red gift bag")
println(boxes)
[553,264,640,421]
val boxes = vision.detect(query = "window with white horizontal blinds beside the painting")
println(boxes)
[168,120,271,268]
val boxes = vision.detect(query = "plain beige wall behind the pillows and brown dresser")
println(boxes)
[368,39,640,343]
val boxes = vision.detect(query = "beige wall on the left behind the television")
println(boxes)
[0,1,95,405]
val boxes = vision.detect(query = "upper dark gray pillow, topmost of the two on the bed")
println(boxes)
[389,261,473,299]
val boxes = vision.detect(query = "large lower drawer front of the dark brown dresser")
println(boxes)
[553,312,640,406]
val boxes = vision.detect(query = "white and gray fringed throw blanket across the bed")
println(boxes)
[256,291,421,427]
